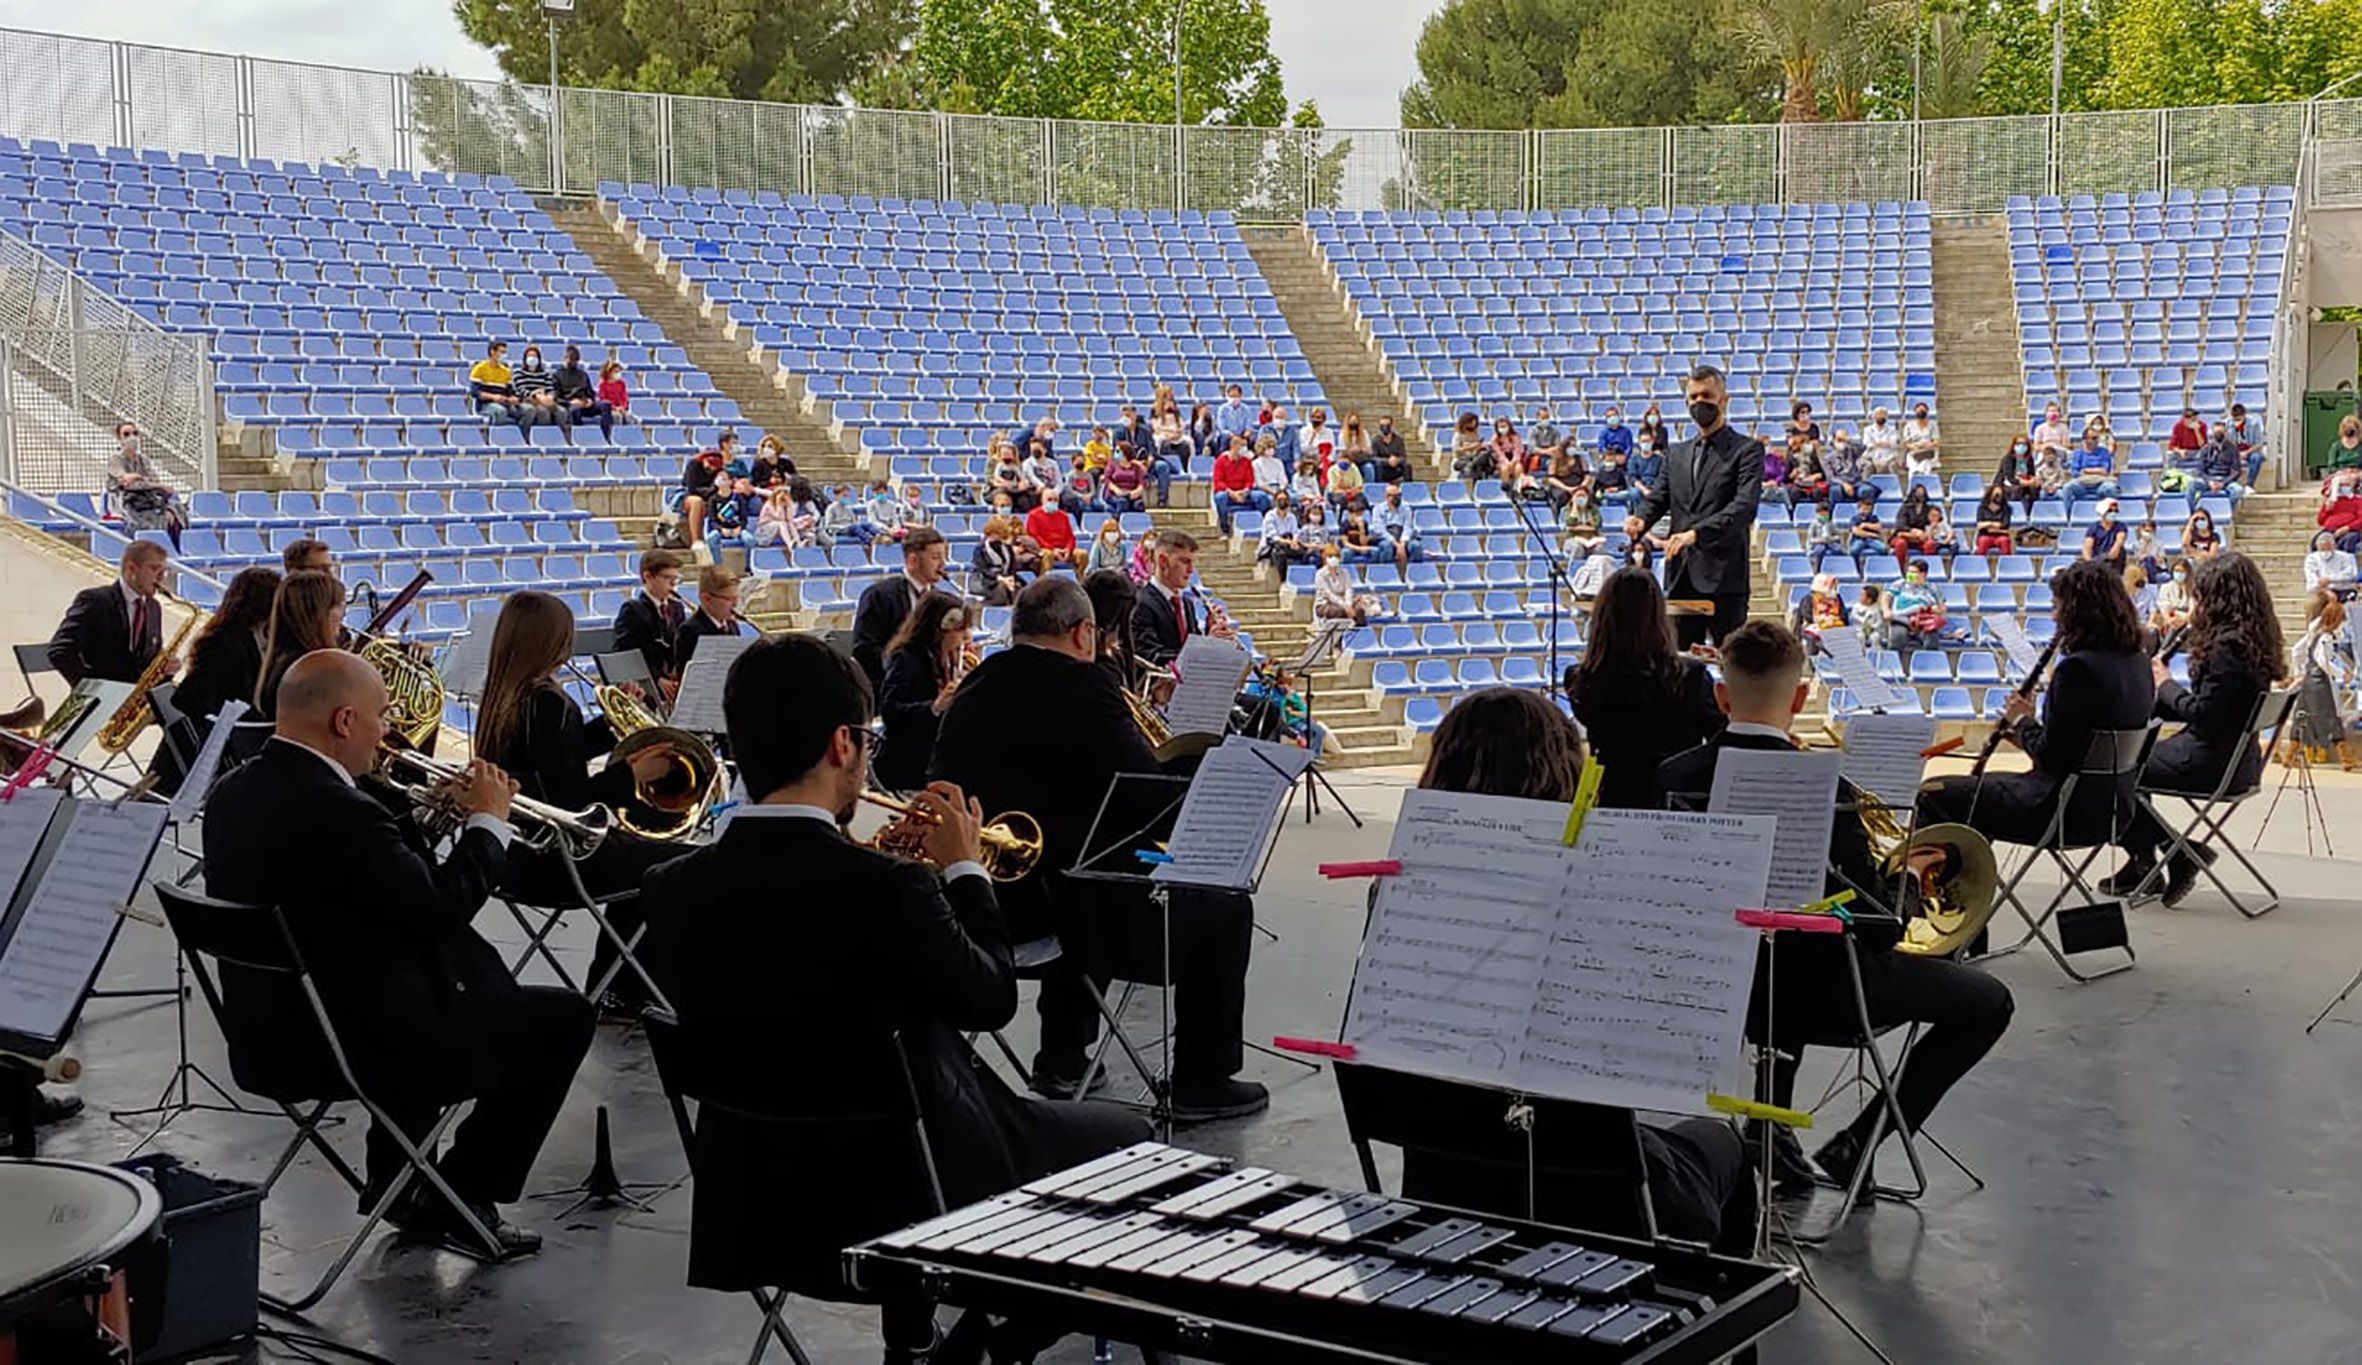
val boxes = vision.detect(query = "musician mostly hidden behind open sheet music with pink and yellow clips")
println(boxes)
[1403,687,1755,1254]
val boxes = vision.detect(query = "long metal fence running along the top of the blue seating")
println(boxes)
[0,31,2362,220]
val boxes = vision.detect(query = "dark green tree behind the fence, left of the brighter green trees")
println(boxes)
[451,0,916,104]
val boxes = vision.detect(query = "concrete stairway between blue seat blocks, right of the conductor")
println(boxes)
[1927,217,2027,462]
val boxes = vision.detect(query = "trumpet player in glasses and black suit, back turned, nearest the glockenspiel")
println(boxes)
[642,635,1148,1346]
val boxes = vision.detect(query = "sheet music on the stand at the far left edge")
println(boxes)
[0,801,170,1039]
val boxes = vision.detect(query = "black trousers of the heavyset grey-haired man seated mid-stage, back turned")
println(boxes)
[1035,888,1254,1084]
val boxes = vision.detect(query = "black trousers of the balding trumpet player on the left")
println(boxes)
[364,985,593,1207]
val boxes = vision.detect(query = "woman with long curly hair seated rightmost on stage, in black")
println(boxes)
[2105,550,2289,904]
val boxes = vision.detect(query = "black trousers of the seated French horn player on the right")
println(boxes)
[1748,945,2017,1136]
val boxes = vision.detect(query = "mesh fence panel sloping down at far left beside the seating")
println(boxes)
[0,231,215,494]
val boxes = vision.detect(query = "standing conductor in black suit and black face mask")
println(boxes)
[1625,364,1764,647]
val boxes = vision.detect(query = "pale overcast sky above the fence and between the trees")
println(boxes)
[0,0,1438,128]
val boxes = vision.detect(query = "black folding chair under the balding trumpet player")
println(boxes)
[156,881,503,1313]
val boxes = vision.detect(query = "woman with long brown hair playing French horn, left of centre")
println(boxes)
[475,590,680,1004]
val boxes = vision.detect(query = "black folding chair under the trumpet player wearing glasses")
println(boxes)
[640,1008,945,1365]
